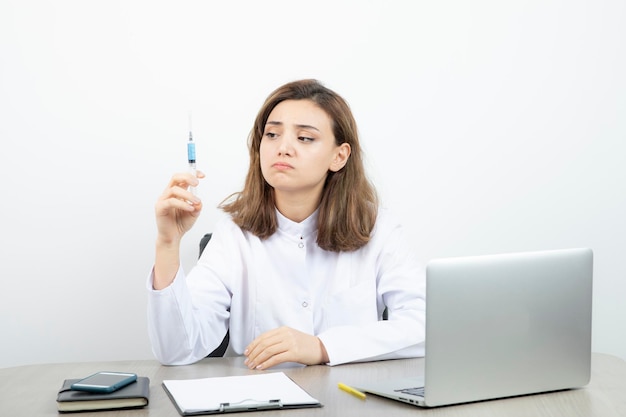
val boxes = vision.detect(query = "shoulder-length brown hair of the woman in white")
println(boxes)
[220,80,378,252]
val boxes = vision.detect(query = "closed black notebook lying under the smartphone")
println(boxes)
[57,376,150,413]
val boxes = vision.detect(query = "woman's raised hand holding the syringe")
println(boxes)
[155,171,204,246]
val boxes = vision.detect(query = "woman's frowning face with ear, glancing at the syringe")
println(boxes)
[260,100,350,197]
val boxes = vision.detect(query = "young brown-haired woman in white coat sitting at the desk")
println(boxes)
[148,80,425,369]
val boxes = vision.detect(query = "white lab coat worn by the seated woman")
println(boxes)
[148,209,425,365]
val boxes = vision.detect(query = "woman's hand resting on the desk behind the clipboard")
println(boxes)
[244,326,328,369]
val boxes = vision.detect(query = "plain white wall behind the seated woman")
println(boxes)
[0,0,626,367]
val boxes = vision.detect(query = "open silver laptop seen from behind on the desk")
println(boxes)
[354,249,593,407]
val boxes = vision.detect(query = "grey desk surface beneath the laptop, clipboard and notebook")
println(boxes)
[0,353,626,417]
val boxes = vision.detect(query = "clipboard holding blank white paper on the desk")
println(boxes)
[162,372,322,416]
